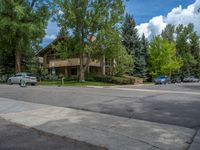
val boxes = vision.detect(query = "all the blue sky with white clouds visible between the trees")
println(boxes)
[42,0,200,46]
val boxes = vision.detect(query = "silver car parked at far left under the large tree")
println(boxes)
[8,72,37,85]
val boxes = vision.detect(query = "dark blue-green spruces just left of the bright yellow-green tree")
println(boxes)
[122,14,147,77]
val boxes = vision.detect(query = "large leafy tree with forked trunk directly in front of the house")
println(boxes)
[54,0,124,81]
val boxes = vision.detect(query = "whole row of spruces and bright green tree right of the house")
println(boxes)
[122,14,200,79]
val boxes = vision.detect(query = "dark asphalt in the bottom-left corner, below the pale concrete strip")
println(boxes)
[0,118,106,150]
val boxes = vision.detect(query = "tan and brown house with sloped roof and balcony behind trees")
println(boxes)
[38,38,111,78]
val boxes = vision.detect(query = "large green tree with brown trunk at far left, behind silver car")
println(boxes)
[0,0,49,72]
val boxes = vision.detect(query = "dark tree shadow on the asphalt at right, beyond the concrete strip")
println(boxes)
[87,94,200,129]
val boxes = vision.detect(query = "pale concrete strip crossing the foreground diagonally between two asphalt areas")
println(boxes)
[0,98,195,150]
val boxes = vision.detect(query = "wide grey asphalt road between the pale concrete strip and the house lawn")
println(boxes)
[0,83,200,129]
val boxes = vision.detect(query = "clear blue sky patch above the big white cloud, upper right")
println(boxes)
[126,0,195,24]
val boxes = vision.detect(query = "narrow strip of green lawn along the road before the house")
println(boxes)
[38,81,114,86]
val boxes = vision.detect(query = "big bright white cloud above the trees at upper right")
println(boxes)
[137,0,200,39]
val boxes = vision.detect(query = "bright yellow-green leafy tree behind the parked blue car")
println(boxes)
[148,36,182,77]
